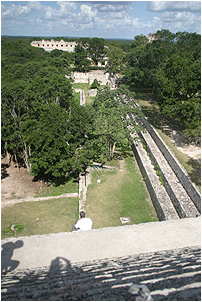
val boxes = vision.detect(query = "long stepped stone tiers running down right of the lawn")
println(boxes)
[129,114,201,220]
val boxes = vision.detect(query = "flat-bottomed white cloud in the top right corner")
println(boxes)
[147,1,201,12]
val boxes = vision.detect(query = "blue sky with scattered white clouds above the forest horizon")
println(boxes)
[1,1,201,39]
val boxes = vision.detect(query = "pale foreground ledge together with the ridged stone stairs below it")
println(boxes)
[1,217,201,301]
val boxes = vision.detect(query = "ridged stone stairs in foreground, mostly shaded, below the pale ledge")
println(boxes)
[1,246,201,301]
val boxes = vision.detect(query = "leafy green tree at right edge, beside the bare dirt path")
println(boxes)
[156,54,201,141]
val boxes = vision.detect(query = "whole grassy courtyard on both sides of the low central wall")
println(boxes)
[1,156,158,239]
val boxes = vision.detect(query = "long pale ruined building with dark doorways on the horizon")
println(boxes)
[31,39,77,52]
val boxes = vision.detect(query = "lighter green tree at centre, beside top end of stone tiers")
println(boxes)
[90,87,143,161]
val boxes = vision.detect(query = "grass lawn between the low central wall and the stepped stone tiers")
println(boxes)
[86,157,158,228]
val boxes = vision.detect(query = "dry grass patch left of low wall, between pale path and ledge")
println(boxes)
[1,198,78,239]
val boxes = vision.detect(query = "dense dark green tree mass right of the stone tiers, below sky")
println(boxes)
[124,30,201,142]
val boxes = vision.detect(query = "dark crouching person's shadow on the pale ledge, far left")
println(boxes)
[1,240,24,275]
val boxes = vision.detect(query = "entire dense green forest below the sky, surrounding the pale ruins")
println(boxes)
[1,30,201,181]
